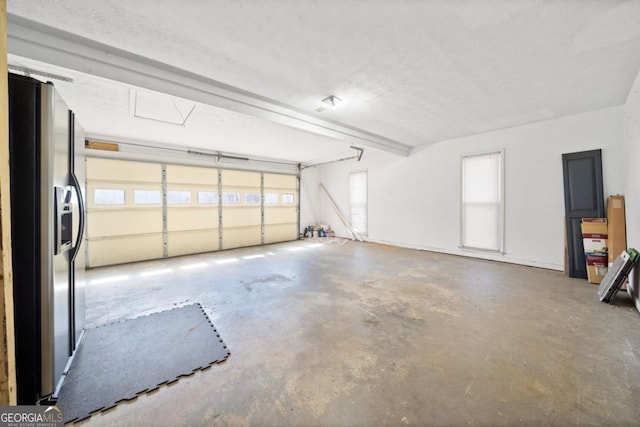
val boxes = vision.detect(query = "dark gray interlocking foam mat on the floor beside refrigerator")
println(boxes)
[57,304,230,423]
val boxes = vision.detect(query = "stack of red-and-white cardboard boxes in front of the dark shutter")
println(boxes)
[581,218,609,283]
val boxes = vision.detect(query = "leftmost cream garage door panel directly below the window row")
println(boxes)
[87,210,162,238]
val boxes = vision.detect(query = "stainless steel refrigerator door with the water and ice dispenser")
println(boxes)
[40,84,73,396]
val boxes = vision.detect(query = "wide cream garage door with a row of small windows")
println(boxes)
[87,158,299,267]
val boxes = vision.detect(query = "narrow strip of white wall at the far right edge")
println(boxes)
[624,70,640,310]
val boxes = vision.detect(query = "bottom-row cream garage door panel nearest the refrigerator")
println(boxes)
[89,234,162,267]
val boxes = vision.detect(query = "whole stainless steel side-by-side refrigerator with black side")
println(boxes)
[9,74,85,404]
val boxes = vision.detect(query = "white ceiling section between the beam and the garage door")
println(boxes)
[8,55,354,163]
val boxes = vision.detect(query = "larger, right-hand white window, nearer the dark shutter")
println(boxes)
[461,150,504,252]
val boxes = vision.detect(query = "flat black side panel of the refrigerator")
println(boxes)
[9,74,42,405]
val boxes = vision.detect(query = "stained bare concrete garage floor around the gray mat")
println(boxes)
[80,239,640,426]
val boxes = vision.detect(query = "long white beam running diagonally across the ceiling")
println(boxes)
[7,14,412,156]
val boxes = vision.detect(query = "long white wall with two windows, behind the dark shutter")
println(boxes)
[303,107,624,270]
